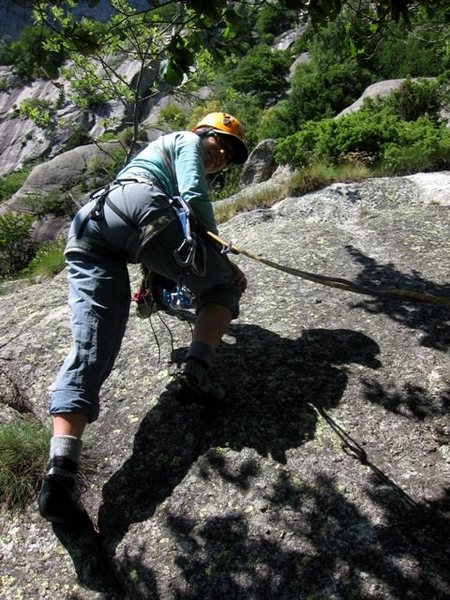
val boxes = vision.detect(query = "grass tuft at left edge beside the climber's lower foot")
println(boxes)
[0,419,50,510]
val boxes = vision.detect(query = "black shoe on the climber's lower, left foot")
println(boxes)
[38,475,91,526]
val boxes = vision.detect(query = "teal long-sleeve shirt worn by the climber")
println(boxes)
[118,131,217,233]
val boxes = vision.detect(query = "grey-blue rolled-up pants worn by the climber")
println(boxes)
[50,183,241,422]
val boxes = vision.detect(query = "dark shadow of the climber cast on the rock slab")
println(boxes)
[98,325,380,552]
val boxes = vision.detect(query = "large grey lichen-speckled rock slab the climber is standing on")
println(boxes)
[0,172,450,600]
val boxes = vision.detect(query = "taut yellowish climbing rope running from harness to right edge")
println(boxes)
[206,231,450,309]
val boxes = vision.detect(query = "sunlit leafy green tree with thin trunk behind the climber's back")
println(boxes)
[29,0,264,156]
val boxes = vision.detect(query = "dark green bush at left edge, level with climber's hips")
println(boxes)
[0,212,34,276]
